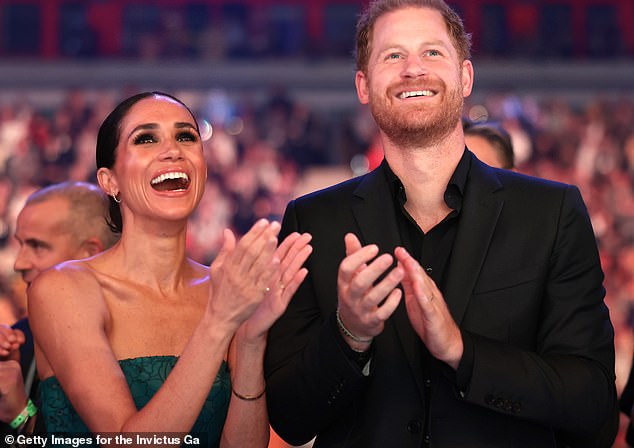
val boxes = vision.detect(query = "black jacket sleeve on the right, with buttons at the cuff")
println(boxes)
[458,186,618,440]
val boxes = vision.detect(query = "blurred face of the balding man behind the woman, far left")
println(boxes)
[13,198,81,285]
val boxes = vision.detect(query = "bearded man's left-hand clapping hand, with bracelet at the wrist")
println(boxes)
[337,233,404,351]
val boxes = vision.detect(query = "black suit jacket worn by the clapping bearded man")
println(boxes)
[265,154,618,448]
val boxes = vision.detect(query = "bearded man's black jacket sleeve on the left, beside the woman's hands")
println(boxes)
[264,202,367,445]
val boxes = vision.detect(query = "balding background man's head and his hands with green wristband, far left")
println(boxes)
[0,182,118,432]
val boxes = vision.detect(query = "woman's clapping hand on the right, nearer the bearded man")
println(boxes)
[238,232,313,343]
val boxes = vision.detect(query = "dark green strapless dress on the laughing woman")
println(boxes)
[40,356,231,447]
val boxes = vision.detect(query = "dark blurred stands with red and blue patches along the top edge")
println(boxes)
[0,0,634,61]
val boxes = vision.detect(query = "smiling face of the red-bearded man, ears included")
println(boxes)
[356,7,473,146]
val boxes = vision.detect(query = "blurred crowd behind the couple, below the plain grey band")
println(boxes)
[0,89,634,388]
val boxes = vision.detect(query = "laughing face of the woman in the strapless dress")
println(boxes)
[102,96,207,225]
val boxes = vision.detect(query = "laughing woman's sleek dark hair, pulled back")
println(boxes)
[96,91,199,233]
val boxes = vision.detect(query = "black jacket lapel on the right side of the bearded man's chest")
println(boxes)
[444,157,504,326]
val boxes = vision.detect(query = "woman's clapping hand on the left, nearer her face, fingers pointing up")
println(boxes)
[207,219,280,331]
